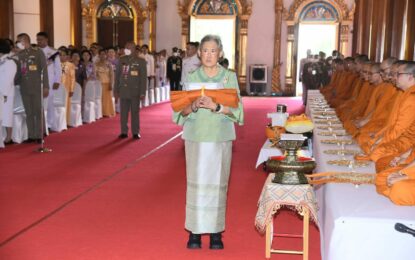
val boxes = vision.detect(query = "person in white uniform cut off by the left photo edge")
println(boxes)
[0,39,17,144]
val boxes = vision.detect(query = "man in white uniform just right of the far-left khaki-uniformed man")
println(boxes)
[36,32,62,128]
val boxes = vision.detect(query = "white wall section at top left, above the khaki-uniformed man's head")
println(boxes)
[13,0,40,43]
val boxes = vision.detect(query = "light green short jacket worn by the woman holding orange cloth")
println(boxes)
[173,66,244,142]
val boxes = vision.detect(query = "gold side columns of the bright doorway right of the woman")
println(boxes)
[282,0,355,95]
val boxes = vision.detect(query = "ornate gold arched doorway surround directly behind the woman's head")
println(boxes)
[178,0,252,94]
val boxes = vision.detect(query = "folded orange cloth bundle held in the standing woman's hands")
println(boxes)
[170,88,239,112]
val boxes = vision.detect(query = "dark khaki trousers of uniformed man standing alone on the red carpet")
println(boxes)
[120,97,140,135]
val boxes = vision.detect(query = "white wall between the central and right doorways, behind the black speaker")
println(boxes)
[246,0,275,93]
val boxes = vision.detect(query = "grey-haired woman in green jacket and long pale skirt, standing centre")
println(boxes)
[173,35,244,249]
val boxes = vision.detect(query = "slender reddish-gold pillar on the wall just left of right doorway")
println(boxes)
[271,0,283,94]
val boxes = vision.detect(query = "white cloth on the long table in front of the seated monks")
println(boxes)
[307,92,415,260]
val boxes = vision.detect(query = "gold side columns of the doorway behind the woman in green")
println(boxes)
[177,0,252,94]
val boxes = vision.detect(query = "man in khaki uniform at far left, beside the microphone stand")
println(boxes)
[17,33,49,143]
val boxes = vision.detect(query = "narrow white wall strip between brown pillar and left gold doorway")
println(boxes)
[53,0,71,48]
